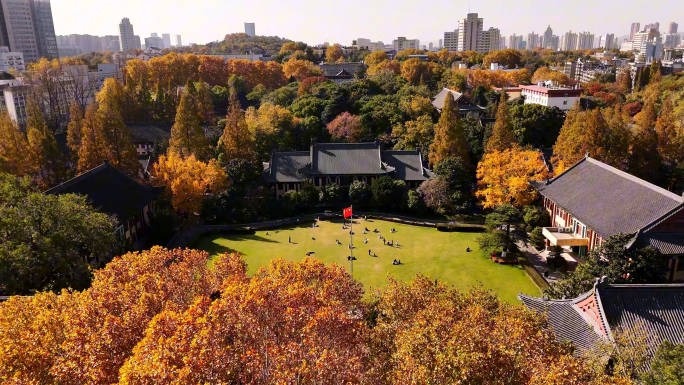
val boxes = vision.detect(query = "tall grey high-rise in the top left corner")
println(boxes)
[0,0,59,62]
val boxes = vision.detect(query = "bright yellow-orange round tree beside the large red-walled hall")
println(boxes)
[475,147,550,208]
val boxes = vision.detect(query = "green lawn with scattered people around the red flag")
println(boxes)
[195,220,540,303]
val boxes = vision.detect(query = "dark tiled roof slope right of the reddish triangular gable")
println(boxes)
[597,284,684,364]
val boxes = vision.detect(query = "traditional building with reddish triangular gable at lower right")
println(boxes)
[518,280,684,370]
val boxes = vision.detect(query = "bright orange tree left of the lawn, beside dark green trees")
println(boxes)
[152,151,230,214]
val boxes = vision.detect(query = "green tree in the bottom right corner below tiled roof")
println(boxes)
[643,341,684,385]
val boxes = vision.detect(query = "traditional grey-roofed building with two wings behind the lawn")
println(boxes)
[264,142,432,197]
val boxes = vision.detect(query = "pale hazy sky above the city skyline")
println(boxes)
[51,0,684,45]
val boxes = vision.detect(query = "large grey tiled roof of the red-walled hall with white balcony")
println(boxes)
[532,157,684,238]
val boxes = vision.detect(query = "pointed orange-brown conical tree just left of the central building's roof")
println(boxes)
[219,93,254,160]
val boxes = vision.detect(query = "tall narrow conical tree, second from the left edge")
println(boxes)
[26,99,66,189]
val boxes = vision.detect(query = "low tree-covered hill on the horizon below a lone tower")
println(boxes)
[206,33,291,55]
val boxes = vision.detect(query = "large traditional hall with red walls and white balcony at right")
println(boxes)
[532,156,684,281]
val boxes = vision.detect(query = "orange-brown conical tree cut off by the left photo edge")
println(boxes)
[0,111,34,176]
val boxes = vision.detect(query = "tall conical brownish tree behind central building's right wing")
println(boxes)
[428,92,471,167]
